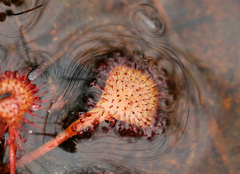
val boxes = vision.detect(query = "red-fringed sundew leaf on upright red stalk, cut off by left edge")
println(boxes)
[0,71,44,174]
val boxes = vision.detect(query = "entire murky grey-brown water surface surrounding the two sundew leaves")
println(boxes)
[0,0,240,174]
